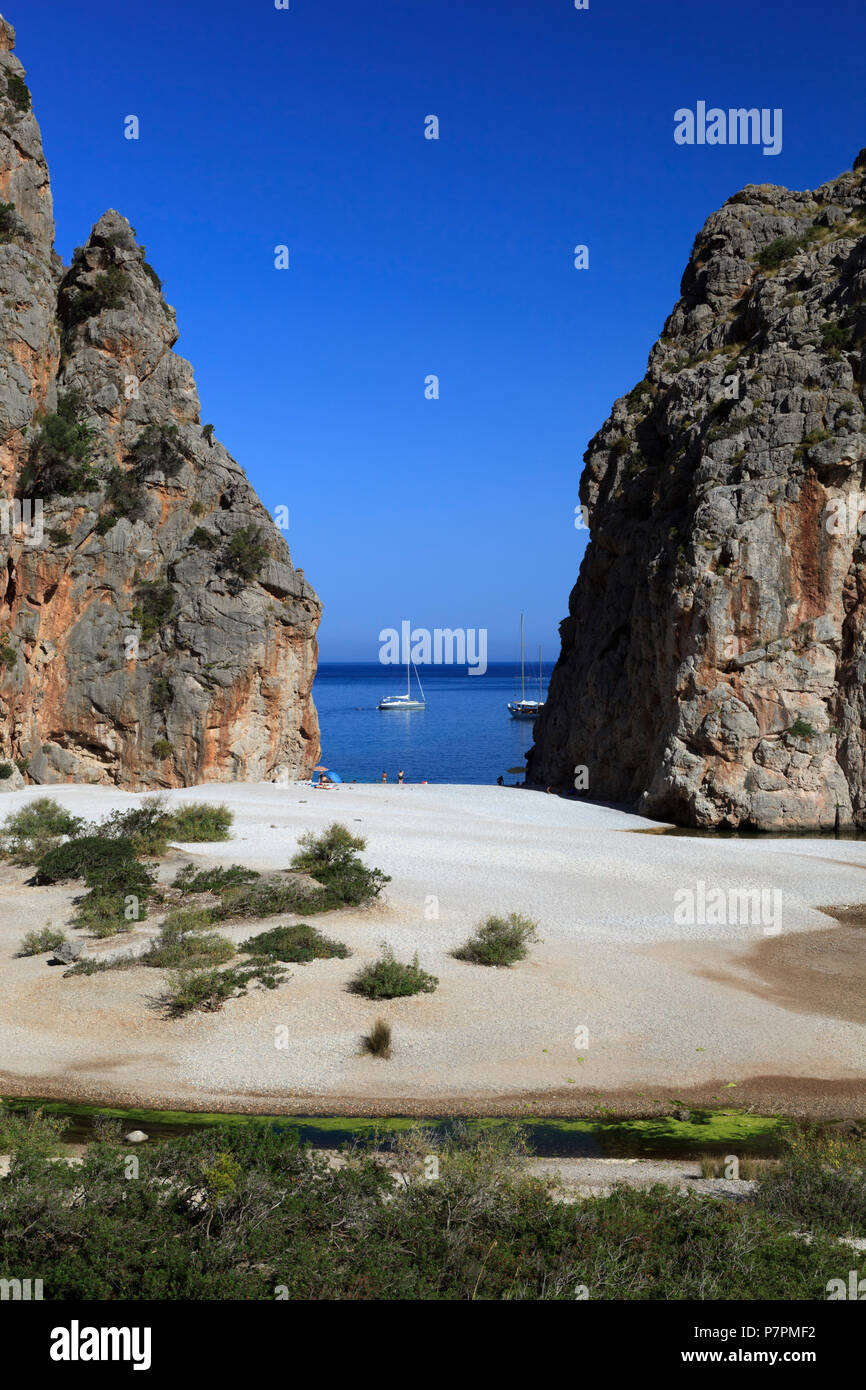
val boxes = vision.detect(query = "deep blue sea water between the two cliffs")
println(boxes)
[313,662,552,784]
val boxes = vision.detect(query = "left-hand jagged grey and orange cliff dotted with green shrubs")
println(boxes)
[0,19,321,788]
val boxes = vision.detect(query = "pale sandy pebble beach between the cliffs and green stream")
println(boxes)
[0,784,866,1115]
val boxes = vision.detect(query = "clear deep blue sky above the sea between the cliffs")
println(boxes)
[15,0,866,660]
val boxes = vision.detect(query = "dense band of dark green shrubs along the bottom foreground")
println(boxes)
[0,1112,856,1295]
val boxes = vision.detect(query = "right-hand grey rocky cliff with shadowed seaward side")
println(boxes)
[528,152,866,828]
